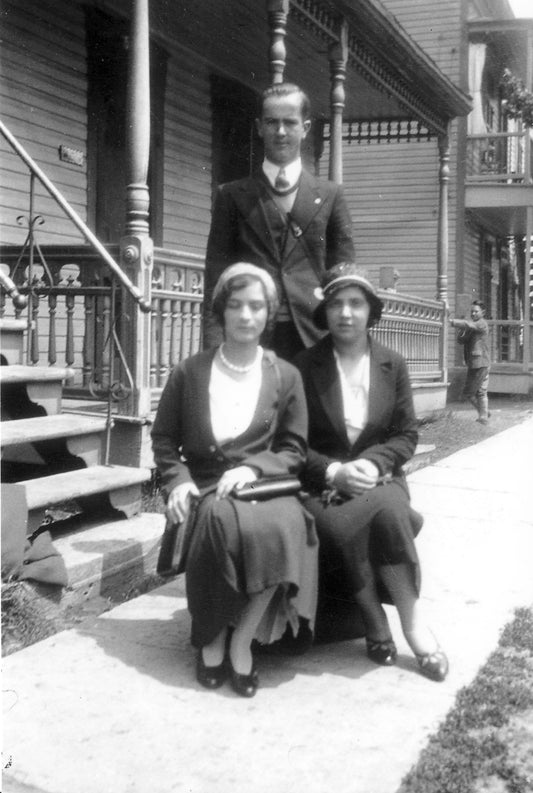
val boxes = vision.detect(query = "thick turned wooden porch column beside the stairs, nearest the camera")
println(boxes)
[119,0,153,430]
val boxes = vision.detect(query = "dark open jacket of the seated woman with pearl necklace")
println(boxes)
[152,350,307,496]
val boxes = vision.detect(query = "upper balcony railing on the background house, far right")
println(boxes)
[466,130,533,184]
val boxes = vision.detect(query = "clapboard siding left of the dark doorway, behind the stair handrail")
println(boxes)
[0,0,87,244]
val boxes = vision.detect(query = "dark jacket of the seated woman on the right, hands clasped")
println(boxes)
[294,336,418,492]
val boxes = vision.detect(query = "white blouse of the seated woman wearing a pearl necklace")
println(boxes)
[209,348,263,444]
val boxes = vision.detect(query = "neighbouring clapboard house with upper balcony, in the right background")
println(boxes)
[350,0,533,398]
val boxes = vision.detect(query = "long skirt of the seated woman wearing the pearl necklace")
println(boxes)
[186,494,318,647]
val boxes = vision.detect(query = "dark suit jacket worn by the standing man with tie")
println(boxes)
[204,171,355,347]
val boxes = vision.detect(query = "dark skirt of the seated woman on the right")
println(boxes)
[305,480,423,641]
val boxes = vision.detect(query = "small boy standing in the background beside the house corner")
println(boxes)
[450,300,490,424]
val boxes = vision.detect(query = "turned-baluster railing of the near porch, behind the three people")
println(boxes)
[0,246,445,398]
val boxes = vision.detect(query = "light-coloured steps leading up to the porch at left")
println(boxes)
[0,322,158,607]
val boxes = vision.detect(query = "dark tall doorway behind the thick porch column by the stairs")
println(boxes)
[86,8,167,245]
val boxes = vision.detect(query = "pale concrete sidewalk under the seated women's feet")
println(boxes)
[3,419,533,793]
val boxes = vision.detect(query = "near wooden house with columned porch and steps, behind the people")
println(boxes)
[0,0,471,576]
